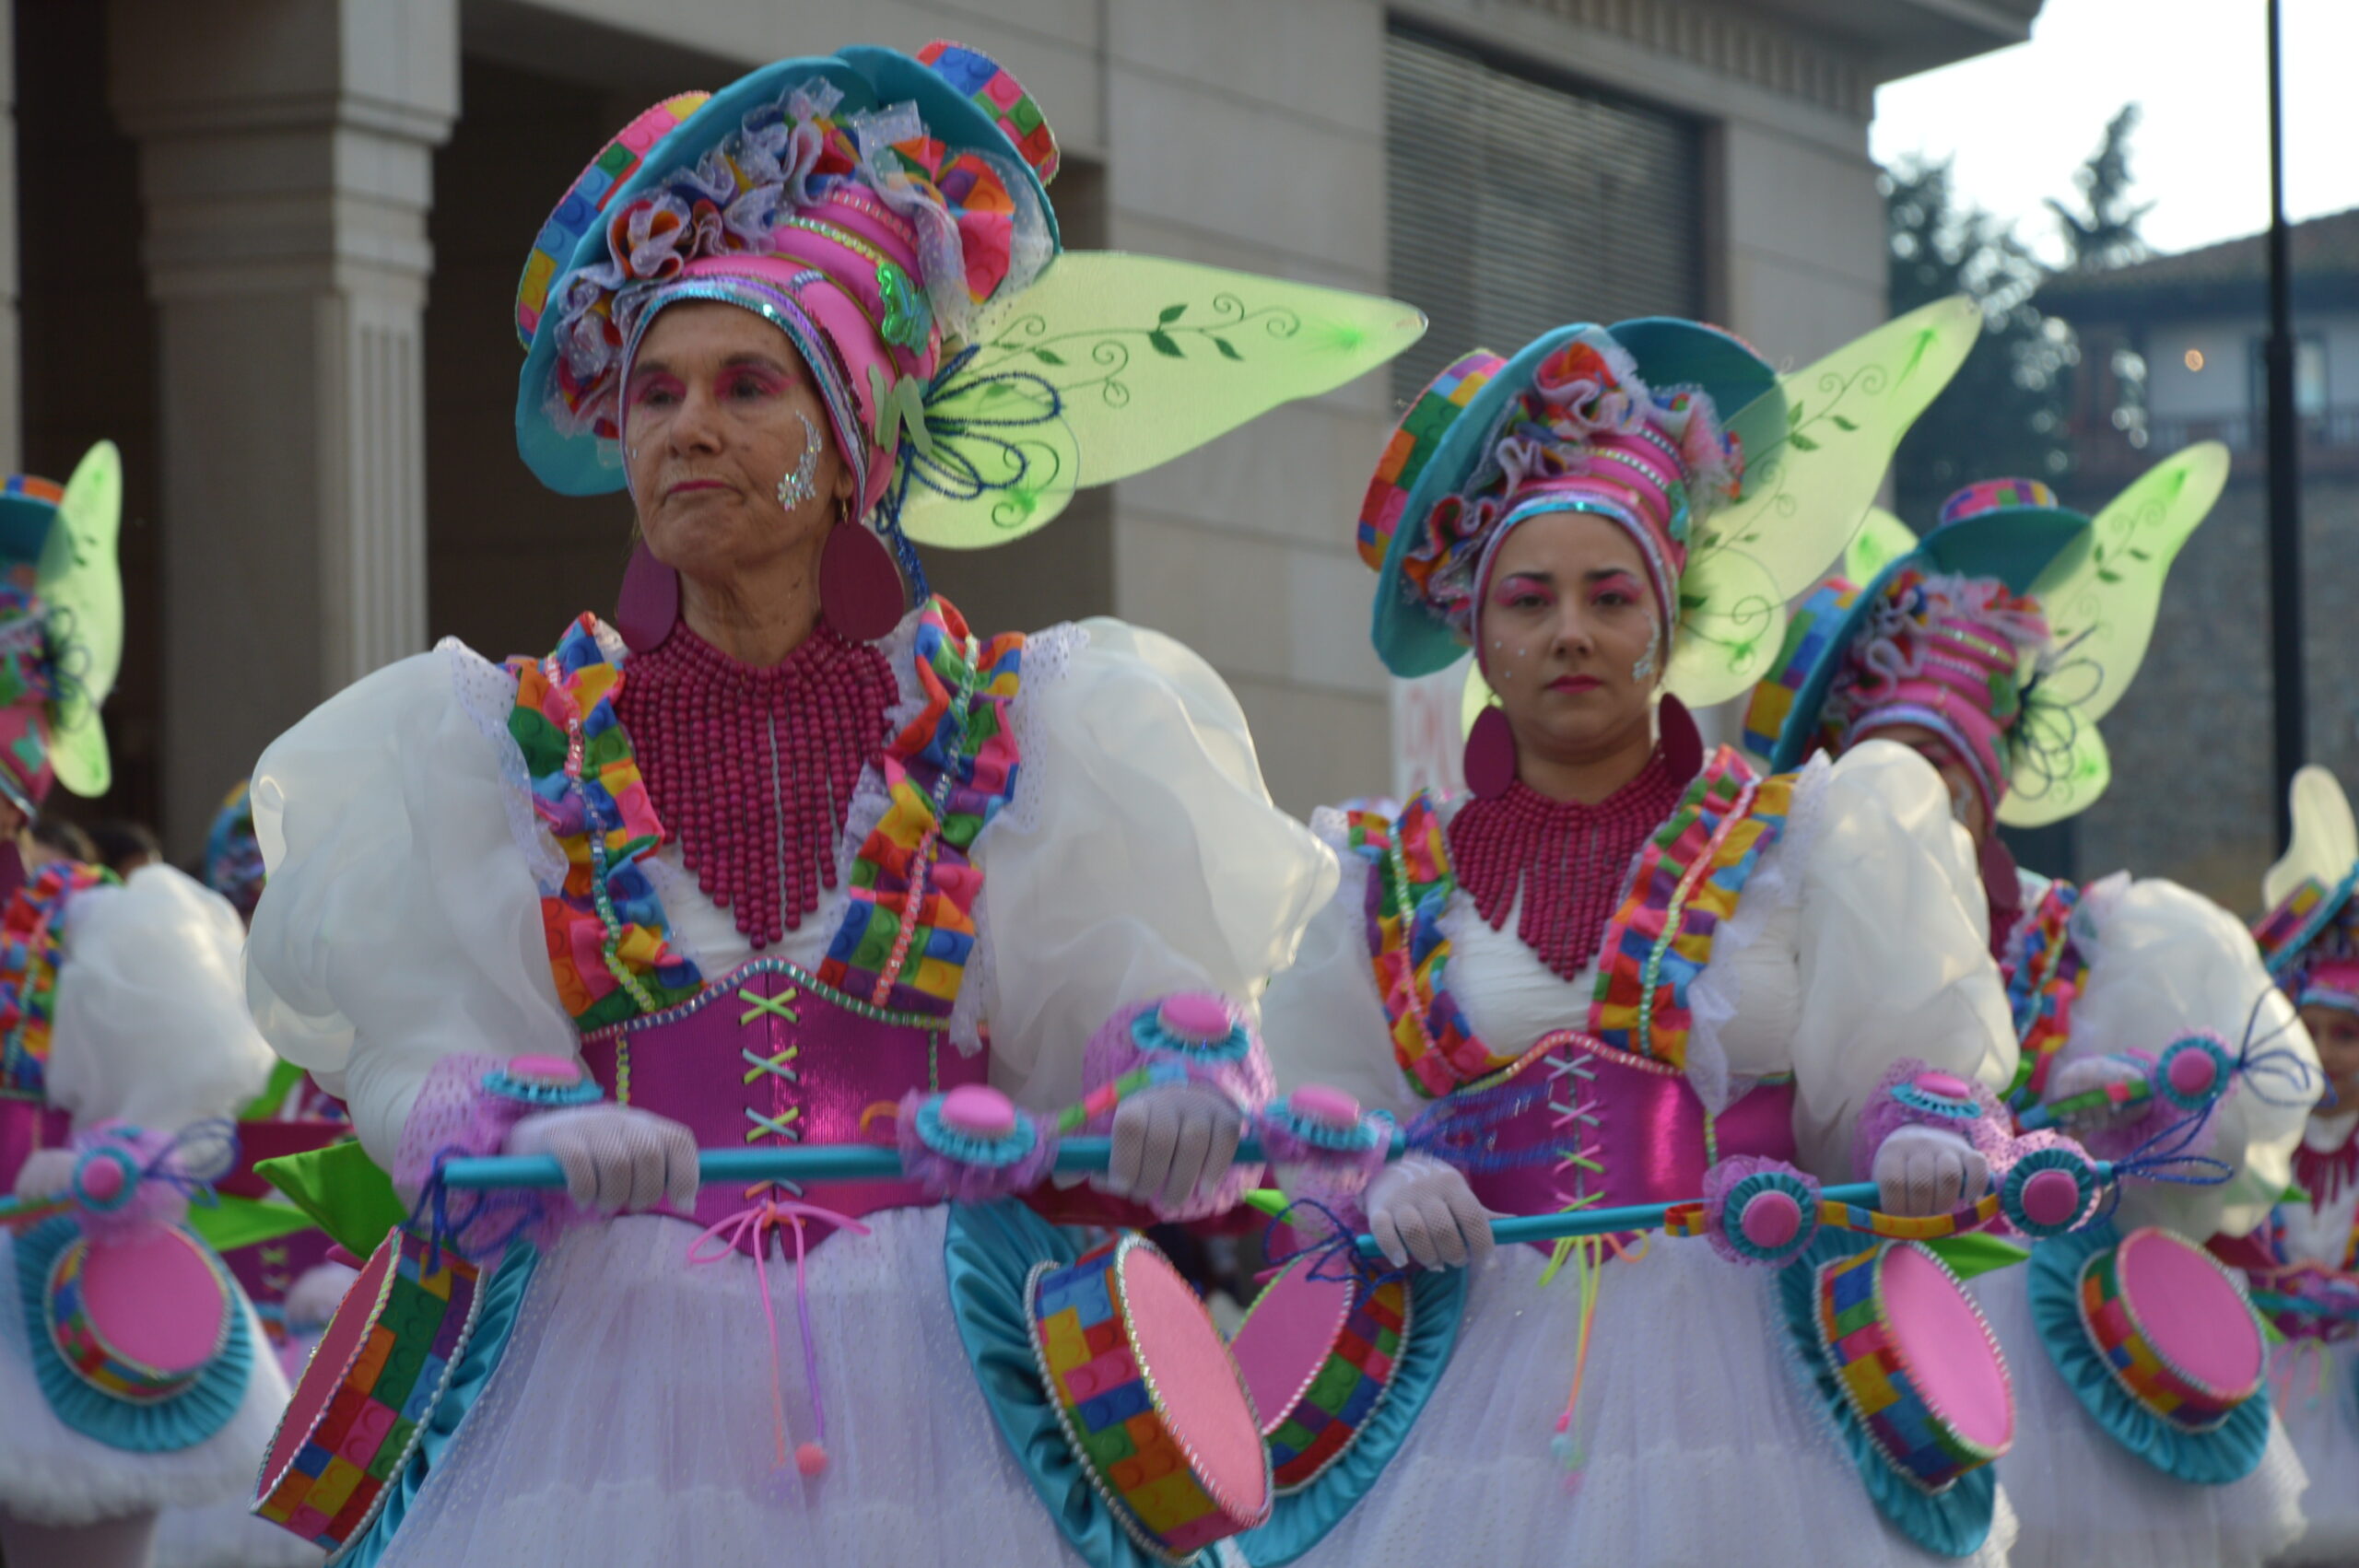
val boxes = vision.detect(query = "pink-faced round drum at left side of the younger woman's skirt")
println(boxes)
[1229,1257,1411,1495]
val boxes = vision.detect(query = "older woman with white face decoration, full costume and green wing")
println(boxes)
[234,45,1423,1568]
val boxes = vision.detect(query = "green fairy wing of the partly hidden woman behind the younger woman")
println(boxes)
[1998,441,2229,827]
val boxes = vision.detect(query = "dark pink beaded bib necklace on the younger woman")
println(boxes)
[1450,747,1686,981]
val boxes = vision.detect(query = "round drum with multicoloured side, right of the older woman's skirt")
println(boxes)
[1027,1235,1272,1563]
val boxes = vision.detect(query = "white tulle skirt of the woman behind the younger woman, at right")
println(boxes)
[1972,1269,2302,1568]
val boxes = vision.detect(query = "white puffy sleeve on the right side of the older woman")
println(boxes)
[969,620,1335,1110]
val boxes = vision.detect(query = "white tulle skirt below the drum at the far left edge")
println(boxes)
[0,1231,288,1527]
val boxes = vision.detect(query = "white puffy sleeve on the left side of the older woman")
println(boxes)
[245,644,578,1169]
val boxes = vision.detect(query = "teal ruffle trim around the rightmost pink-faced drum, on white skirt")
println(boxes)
[2026,1223,2270,1485]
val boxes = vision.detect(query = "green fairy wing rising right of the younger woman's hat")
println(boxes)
[1668,295,1981,708]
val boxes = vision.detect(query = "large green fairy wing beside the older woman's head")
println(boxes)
[901,250,1425,549]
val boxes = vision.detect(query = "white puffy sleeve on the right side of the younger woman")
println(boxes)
[1781,741,2014,1181]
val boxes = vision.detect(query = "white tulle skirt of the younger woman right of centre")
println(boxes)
[1300,1235,2013,1568]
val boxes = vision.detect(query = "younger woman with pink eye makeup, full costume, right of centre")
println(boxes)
[1246,302,2085,1568]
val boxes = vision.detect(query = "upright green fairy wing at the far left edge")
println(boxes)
[38,441,123,795]
